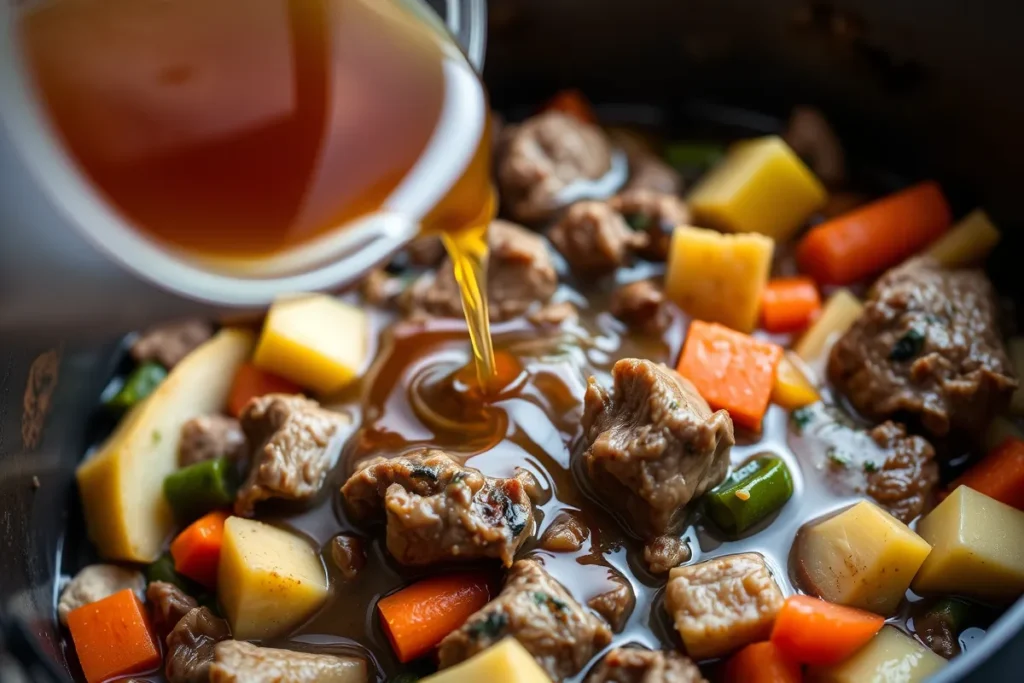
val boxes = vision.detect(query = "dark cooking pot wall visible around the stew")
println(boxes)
[0,0,1024,683]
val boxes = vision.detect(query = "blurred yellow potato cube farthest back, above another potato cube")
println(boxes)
[687,135,828,242]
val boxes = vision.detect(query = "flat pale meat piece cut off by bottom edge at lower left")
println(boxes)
[210,640,367,683]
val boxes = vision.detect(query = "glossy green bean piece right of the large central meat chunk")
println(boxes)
[706,456,793,533]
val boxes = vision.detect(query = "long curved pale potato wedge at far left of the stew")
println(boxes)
[76,329,255,562]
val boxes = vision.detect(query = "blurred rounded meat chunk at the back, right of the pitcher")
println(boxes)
[497,111,611,222]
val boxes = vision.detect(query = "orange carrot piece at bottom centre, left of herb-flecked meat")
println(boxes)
[377,573,490,663]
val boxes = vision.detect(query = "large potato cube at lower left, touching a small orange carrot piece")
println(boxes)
[217,517,327,640]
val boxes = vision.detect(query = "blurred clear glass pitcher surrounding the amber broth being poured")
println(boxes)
[0,0,486,332]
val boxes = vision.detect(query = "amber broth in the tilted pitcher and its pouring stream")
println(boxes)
[20,0,495,381]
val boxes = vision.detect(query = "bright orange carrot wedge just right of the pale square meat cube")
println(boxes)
[771,595,886,667]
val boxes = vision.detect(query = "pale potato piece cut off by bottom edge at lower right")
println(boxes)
[807,626,946,683]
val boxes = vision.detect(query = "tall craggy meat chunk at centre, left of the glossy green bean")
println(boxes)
[580,358,735,538]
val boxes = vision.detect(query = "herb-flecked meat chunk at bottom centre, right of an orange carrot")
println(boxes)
[437,560,611,681]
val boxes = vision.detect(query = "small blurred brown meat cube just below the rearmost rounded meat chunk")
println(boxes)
[548,202,648,278]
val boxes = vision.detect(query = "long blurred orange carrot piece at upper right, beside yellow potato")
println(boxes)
[797,181,952,285]
